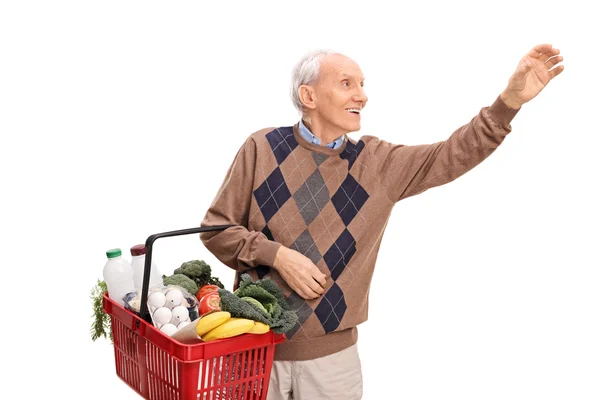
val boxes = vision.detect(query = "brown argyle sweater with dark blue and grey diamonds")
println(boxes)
[201,97,517,360]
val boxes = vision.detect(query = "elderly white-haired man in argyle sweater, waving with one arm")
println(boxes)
[201,44,563,400]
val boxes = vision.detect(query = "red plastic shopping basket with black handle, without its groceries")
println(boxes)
[102,225,285,400]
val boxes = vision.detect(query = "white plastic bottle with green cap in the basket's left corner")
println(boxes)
[102,248,135,307]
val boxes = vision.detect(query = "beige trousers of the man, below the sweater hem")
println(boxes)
[267,344,363,400]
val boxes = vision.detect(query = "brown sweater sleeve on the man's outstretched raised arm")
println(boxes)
[369,96,519,202]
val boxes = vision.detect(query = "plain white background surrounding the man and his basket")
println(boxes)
[0,0,600,400]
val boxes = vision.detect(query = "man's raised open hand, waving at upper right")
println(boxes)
[500,44,565,109]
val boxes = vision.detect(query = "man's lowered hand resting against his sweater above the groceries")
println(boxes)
[273,246,326,300]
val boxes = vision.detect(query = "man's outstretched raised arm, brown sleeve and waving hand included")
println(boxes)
[369,44,564,201]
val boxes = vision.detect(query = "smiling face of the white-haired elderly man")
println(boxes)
[312,54,368,136]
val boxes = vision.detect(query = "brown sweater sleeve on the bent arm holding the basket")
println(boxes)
[200,137,281,271]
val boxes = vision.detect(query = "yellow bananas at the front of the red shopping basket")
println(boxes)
[196,311,271,342]
